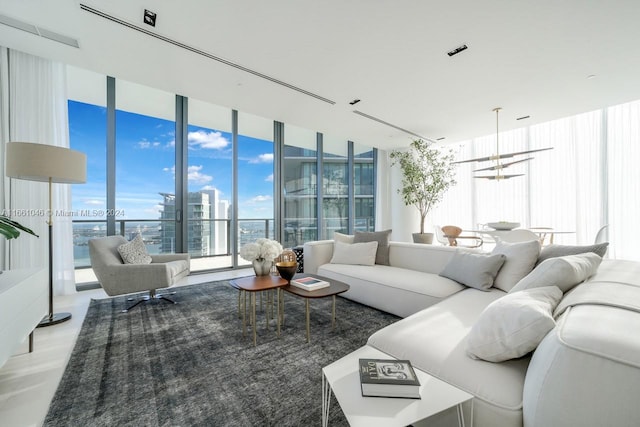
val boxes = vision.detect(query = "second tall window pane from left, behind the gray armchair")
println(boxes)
[114,80,176,253]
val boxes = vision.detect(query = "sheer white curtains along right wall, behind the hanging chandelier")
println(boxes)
[392,101,640,261]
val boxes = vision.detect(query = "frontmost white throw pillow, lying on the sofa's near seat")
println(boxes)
[466,286,562,362]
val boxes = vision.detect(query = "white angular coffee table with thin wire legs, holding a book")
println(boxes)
[322,346,473,427]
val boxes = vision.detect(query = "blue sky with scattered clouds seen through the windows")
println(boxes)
[69,101,273,219]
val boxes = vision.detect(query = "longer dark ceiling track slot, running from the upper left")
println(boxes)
[80,3,336,105]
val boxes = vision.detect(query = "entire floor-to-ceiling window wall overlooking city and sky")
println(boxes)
[68,67,375,282]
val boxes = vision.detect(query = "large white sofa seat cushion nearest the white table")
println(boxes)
[368,288,529,426]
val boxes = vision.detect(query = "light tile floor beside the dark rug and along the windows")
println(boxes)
[0,269,253,427]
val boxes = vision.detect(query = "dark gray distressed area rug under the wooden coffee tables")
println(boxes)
[44,281,398,426]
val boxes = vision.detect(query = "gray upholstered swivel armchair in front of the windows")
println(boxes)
[89,236,189,312]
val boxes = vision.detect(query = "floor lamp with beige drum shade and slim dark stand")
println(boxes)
[6,142,87,327]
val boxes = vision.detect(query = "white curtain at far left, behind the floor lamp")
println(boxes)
[0,46,75,295]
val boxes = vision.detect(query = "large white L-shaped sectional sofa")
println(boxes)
[304,240,640,427]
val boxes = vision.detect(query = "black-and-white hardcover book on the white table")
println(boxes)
[358,359,420,399]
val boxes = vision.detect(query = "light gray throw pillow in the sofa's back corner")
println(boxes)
[439,251,506,291]
